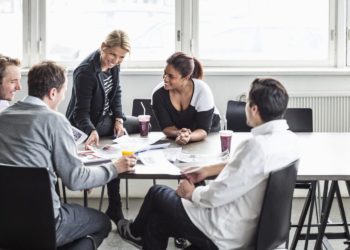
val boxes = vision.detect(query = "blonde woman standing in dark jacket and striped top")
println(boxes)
[66,30,130,227]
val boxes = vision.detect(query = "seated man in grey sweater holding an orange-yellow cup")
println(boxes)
[0,62,136,249]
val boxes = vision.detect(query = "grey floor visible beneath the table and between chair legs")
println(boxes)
[69,198,350,250]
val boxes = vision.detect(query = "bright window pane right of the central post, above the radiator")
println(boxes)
[196,0,334,65]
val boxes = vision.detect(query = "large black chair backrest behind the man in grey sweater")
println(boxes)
[0,164,56,250]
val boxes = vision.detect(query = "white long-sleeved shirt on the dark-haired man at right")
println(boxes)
[182,120,299,249]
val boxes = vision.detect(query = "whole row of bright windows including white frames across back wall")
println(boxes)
[0,0,350,68]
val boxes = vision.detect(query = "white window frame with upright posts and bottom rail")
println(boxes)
[22,0,350,69]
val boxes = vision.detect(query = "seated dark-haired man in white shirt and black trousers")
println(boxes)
[118,78,299,250]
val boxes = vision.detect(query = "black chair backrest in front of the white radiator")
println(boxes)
[284,108,313,132]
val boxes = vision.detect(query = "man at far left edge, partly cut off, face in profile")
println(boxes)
[0,54,22,111]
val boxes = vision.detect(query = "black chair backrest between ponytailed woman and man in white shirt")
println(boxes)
[226,100,252,132]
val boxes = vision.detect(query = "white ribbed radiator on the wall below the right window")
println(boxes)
[288,95,350,132]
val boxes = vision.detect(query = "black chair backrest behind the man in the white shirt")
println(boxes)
[255,161,298,250]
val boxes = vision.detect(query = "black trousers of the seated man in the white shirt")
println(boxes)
[130,185,218,250]
